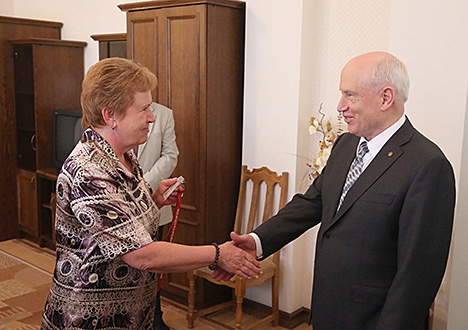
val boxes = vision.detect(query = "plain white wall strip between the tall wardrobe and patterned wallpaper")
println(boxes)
[243,0,303,311]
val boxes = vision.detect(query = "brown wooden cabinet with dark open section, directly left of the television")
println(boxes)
[10,39,86,244]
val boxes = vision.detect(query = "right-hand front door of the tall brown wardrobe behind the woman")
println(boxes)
[158,5,207,296]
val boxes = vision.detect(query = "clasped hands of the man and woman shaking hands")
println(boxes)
[211,232,262,281]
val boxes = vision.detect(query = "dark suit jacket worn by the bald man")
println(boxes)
[255,118,455,330]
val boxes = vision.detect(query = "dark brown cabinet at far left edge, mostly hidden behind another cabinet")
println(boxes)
[0,16,63,241]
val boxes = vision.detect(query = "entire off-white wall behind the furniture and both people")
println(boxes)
[0,0,468,324]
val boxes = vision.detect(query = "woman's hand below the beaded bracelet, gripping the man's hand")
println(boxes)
[218,241,262,279]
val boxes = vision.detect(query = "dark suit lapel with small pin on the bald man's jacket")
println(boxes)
[327,118,415,229]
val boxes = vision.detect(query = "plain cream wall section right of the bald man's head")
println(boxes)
[390,0,468,183]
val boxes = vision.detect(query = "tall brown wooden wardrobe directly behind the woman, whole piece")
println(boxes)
[119,0,245,305]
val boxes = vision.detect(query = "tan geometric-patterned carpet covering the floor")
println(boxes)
[0,239,229,330]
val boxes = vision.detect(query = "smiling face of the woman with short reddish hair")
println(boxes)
[116,92,155,149]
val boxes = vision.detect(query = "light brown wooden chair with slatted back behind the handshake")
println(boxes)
[187,165,288,330]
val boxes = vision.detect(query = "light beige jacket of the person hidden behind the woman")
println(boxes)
[138,102,179,226]
